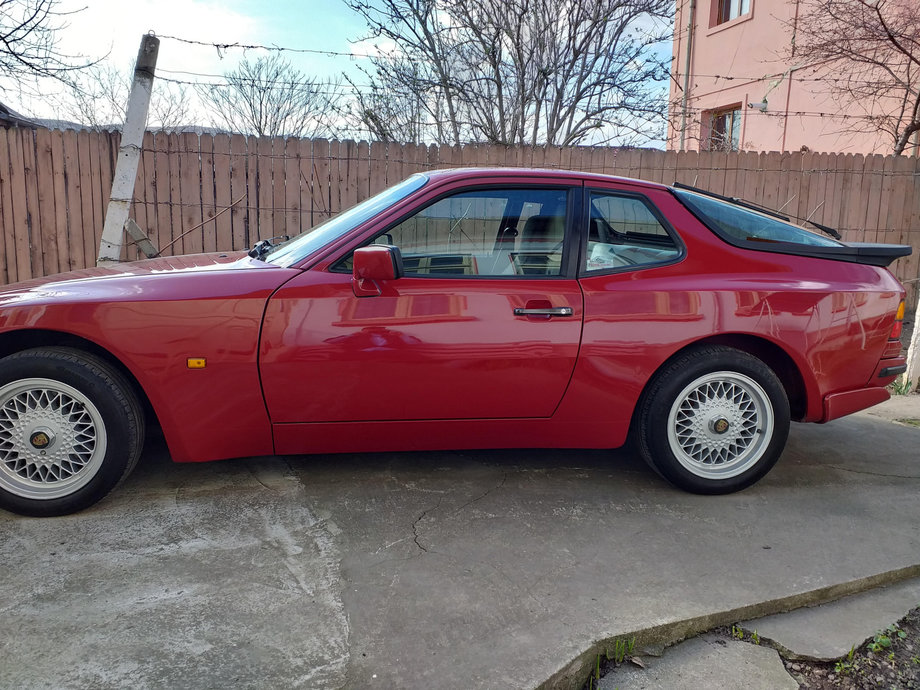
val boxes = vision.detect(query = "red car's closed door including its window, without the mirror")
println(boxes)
[260,184,583,424]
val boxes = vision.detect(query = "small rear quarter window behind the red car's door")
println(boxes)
[585,192,681,272]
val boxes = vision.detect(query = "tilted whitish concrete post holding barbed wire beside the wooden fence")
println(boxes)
[96,34,160,266]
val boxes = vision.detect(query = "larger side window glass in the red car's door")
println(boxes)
[336,188,568,276]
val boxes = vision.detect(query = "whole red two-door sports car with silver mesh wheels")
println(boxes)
[0,170,910,515]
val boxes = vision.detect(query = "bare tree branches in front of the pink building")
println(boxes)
[792,0,920,155]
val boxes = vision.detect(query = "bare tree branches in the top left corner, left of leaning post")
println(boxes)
[0,0,91,92]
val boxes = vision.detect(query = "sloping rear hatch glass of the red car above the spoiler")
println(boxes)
[672,189,843,247]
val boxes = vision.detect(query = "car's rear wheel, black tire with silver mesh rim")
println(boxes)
[636,345,789,494]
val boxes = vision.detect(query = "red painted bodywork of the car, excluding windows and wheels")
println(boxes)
[0,170,904,461]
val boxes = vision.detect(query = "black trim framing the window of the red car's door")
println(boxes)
[327,182,583,281]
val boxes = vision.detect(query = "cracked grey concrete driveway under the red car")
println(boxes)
[0,396,920,688]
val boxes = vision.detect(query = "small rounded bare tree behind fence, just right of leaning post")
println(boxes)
[199,53,337,137]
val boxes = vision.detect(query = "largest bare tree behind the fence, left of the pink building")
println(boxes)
[344,0,672,145]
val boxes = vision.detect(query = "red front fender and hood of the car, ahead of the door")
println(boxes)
[0,256,299,461]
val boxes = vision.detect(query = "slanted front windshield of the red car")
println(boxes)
[265,173,428,268]
